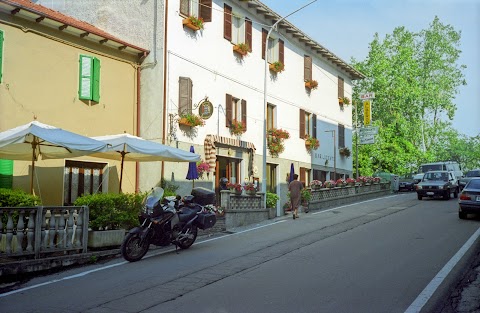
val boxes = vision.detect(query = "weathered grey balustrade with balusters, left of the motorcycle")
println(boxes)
[0,206,89,259]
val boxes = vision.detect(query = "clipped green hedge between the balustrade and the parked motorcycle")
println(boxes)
[74,193,145,230]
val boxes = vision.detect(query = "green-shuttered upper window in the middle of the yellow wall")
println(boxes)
[78,55,100,102]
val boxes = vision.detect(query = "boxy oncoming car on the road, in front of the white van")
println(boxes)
[417,171,458,200]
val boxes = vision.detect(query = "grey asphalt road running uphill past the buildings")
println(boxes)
[0,193,480,313]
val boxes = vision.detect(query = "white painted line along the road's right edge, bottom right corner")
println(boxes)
[405,228,480,313]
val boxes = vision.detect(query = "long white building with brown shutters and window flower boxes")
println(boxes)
[34,0,364,212]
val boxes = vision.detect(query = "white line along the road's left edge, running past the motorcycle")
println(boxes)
[0,220,287,298]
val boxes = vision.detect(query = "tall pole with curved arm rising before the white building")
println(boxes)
[262,0,318,216]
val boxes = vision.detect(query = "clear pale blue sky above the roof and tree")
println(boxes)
[260,0,480,136]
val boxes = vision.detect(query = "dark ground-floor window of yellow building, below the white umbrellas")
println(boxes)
[63,160,108,205]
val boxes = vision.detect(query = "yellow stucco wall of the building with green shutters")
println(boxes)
[0,15,141,205]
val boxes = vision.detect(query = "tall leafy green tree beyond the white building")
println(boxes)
[352,17,466,175]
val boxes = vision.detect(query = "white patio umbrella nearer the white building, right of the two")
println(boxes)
[91,133,200,192]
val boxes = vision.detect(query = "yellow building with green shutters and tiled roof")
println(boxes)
[0,0,148,205]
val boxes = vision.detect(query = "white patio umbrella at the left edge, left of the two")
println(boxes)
[0,121,106,193]
